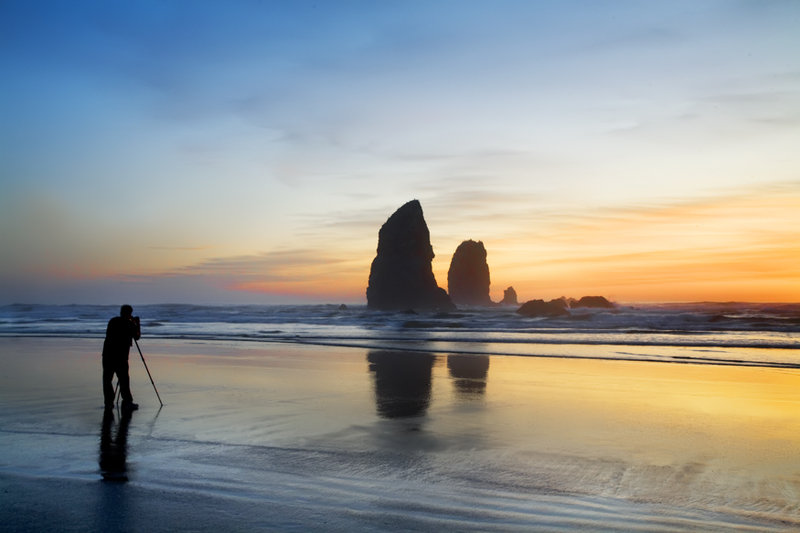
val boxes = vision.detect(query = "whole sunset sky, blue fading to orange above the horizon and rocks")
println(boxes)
[0,0,800,304]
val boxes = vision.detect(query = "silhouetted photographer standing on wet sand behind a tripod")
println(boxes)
[103,305,142,411]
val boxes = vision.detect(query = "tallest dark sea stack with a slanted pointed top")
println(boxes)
[367,200,455,310]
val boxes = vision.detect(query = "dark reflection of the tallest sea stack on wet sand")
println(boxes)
[367,351,436,418]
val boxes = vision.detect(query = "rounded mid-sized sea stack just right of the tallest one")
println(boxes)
[447,240,492,305]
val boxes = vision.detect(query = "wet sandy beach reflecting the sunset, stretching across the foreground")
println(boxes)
[0,338,800,531]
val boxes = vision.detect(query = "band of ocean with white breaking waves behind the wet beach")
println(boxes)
[0,303,800,368]
